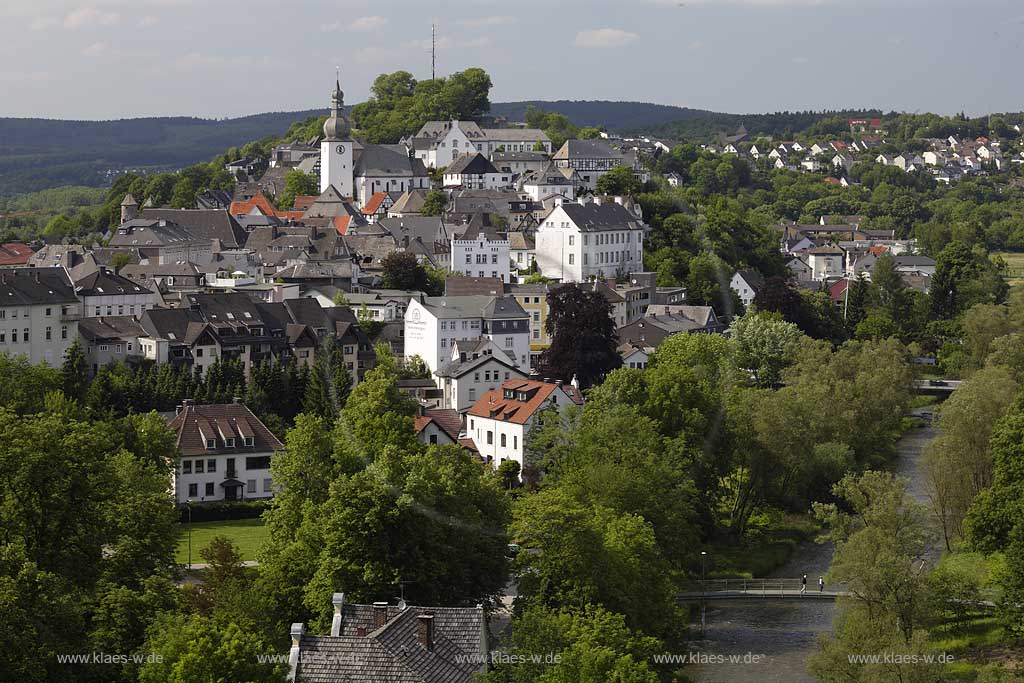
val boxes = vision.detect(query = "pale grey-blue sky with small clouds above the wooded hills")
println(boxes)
[0,0,1024,119]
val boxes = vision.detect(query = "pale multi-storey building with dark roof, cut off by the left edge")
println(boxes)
[0,268,80,368]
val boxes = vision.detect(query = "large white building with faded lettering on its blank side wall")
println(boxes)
[404,296,529,373]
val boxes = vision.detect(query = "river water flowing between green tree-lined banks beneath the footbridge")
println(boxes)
[686,413,935,683]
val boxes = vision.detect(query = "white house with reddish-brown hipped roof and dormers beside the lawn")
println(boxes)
[168,399,285,505]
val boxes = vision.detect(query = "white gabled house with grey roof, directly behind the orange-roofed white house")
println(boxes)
[434,339,526,413]
